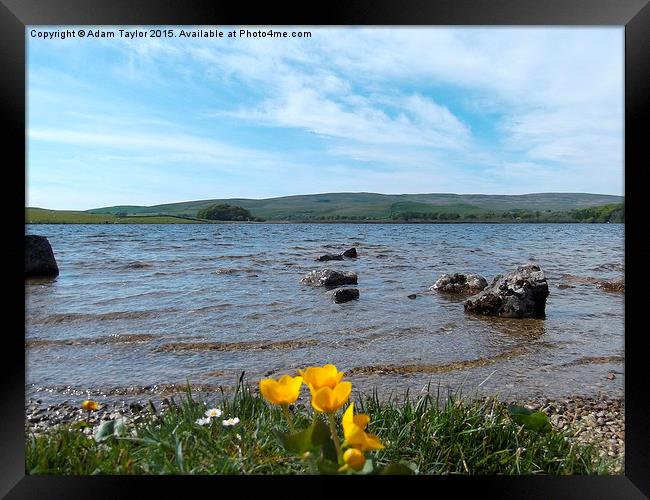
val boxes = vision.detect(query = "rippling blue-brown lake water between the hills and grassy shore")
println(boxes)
[25,224,624,401]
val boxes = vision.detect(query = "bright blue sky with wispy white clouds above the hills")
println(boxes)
[26,26,624,210]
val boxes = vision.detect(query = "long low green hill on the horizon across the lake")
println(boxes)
[86,193,624,221]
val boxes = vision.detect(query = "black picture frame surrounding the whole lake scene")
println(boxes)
[0,0,650,499]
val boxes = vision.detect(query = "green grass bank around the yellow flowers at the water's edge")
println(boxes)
[26,385,611,475]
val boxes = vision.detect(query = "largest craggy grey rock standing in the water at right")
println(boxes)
[465,264,548,318]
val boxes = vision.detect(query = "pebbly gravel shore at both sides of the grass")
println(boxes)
[25,395,625,474]
